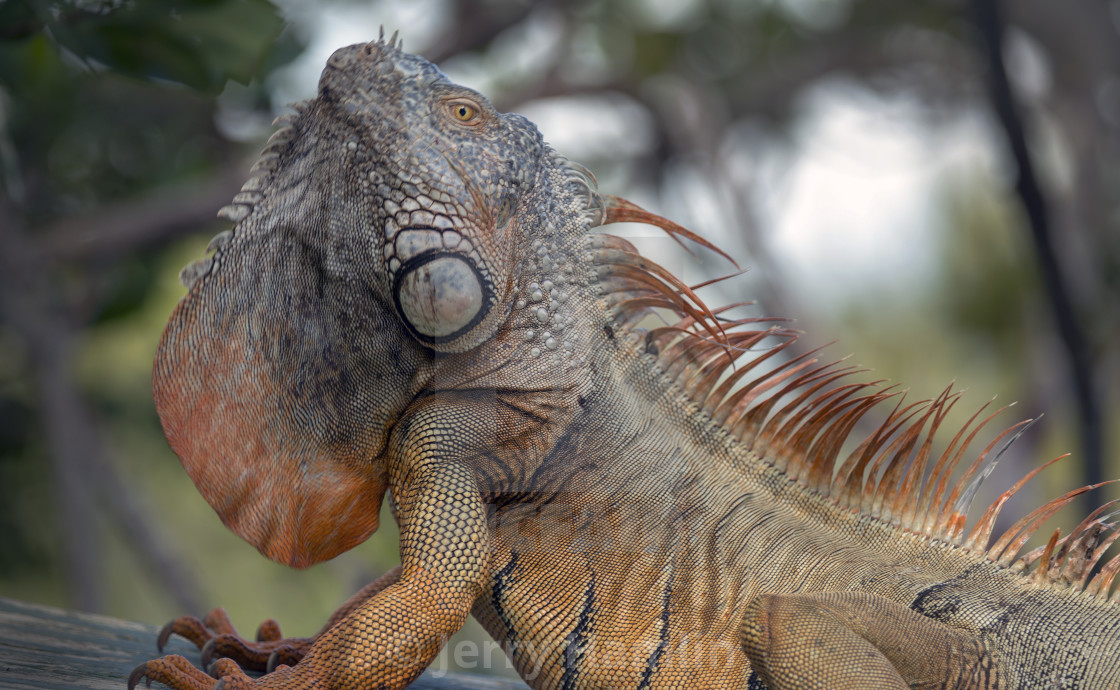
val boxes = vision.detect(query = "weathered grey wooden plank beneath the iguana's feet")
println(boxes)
[0,597,525,690]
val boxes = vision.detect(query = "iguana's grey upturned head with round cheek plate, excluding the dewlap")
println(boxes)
[318,36,543,352]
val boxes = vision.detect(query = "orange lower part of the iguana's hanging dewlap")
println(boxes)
[152,297,385,568]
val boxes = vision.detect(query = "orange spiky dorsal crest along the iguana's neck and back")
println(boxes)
[590,197,1120,602]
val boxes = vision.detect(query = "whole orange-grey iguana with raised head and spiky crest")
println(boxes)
[129,35,1120,690]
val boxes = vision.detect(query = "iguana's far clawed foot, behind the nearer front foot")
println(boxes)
[156,608,311,672]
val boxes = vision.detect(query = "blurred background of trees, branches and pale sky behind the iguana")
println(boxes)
[0,0,1120,681]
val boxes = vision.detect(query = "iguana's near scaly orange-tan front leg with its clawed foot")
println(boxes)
[131,407,489,690]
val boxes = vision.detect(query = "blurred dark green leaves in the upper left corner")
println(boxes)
[0,0,295,227]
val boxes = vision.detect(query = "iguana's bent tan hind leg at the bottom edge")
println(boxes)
[740,591,1002,690]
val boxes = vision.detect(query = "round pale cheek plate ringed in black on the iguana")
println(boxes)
[395,254,489,343]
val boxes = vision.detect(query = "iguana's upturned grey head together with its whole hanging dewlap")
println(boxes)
[152,35,543,566]
